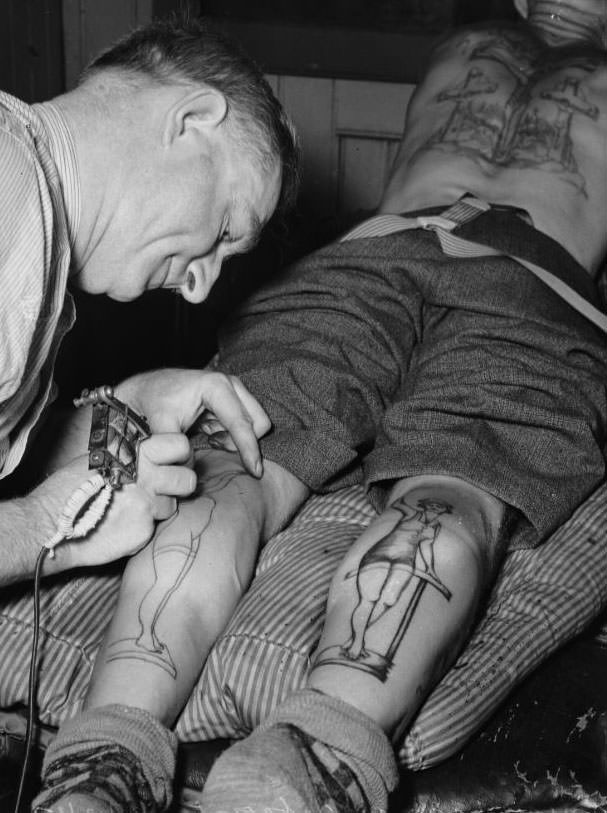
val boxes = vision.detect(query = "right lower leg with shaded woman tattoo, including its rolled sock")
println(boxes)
[202,477,505,813]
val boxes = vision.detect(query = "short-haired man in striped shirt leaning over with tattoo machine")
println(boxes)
[0,21,298,585]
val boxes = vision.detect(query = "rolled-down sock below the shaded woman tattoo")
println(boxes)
[201,689,398,813]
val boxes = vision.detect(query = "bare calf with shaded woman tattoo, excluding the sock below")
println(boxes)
[309,477,504,734]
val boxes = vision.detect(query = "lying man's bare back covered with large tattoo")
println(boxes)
[380,27,607,275]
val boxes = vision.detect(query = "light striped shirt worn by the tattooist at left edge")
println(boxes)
[0,93,80,478]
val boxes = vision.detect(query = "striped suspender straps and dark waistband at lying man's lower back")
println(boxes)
[341,196,607,332]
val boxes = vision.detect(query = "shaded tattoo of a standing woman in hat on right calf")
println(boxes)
[315,497,451,681]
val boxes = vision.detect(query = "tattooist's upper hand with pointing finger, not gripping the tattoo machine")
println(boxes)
[115,369,270,477]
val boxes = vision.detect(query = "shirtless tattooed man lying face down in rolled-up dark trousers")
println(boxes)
[32,0,607,813]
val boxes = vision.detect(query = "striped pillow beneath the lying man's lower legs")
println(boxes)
[0,484,607,770]
